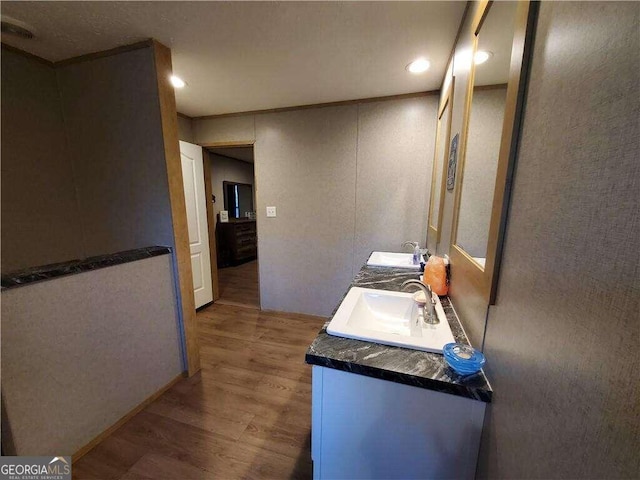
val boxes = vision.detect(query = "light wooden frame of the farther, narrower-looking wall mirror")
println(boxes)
[427,76,455,254]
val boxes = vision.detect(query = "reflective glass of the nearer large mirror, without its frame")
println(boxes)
[455,2,517,268]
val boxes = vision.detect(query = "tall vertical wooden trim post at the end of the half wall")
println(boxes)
[152,41,200,376]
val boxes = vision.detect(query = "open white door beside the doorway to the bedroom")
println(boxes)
[180,141,213,308]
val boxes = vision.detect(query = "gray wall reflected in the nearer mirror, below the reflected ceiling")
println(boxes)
[456,87,507,258]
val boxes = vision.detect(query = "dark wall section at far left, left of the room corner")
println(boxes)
[1,49,85,273]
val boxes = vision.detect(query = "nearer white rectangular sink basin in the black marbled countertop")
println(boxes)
[327,287,455,353]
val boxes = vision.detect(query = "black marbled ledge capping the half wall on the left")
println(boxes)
[2,246,171,291]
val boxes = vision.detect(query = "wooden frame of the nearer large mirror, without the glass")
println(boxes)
[449,0,534,305]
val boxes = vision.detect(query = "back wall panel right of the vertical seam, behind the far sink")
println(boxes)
[353,95,438,275]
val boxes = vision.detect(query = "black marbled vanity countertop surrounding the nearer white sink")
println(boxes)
[306,265,492,402]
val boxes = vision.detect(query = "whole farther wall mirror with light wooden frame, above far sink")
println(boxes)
[427,79,453,253]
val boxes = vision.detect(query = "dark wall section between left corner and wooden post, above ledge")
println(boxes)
[57,48,174,255]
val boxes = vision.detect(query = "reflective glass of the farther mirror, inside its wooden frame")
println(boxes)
[429,88,452,250]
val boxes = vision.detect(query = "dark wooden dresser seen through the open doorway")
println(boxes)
[216,218,258,267]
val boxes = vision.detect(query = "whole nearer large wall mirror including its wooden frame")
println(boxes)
[450,1,529,304]
